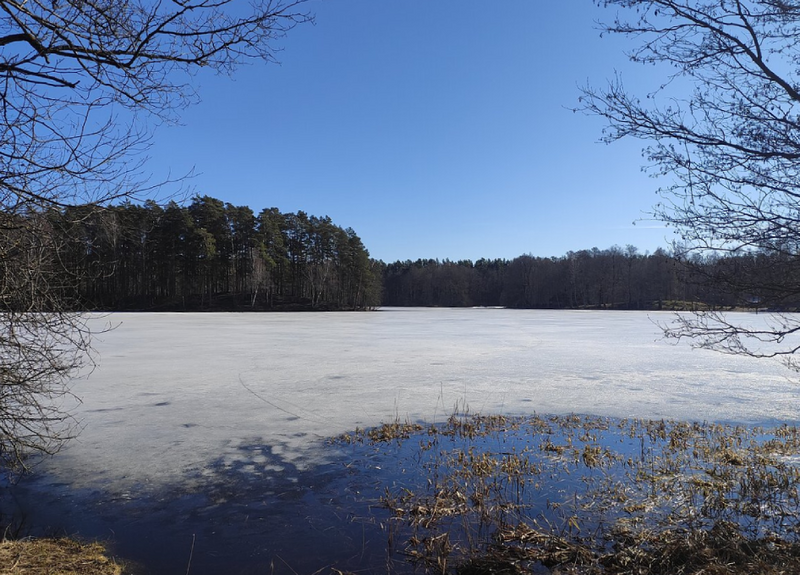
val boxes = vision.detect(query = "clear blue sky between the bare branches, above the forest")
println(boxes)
[150,0,672,262]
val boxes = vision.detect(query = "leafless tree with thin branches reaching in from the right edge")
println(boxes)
[582,0,800,364]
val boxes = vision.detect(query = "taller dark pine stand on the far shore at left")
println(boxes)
[47,196,380,310]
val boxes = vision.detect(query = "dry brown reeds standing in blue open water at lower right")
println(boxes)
[339,415,800,575]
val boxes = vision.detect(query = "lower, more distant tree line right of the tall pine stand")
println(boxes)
[382,245,788,310]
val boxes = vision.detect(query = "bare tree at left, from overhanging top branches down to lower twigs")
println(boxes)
[0,0,309,467]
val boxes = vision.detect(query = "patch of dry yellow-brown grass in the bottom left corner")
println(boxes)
[0,539,122,575]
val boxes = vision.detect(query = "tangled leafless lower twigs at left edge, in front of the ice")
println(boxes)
[0,209,91,470]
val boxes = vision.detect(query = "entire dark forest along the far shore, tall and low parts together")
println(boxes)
[37,196,780,311]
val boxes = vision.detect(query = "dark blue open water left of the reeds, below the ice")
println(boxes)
[0,442,396,575]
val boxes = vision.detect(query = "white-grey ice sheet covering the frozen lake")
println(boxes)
[56,308,800,496]
